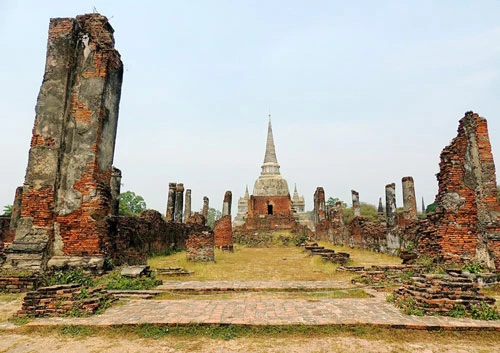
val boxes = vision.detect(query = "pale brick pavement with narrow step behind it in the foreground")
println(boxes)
[11,281,500,331]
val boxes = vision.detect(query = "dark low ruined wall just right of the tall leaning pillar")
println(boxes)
[106,210,210,265]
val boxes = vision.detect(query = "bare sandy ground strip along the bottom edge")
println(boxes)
[0,332,500,353]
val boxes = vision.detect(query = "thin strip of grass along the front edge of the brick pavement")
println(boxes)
[15,324,500,344]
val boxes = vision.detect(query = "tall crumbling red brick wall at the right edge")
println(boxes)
[418,112,500,270]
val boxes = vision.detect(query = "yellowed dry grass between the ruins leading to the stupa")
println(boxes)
[148,244,401,281]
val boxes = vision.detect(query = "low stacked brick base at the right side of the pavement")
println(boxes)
[395,273,495,315]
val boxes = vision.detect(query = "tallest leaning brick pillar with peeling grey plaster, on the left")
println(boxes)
[5,13,123,271]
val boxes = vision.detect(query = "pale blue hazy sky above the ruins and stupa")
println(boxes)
[0,0,500,214]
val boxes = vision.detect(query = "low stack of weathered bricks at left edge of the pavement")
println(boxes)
[17,284,112,317]
